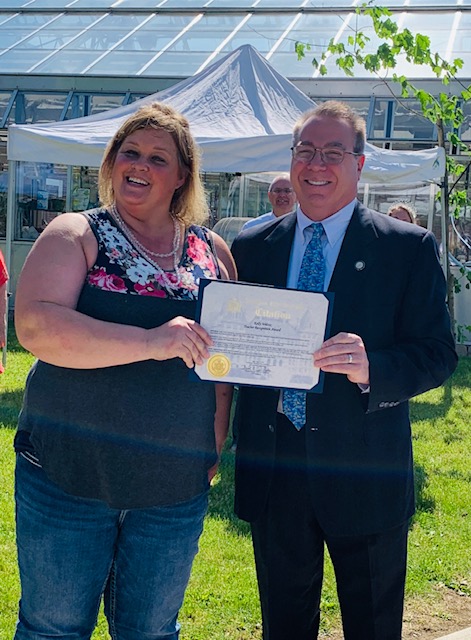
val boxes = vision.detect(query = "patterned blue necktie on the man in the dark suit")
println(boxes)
[283,223,325,431]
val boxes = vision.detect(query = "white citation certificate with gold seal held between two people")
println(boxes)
[194,279,333,392]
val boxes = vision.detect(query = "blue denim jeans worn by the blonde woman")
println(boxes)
[15,455,208,640]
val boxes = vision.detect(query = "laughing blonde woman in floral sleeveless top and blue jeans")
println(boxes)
[15,103,236,640]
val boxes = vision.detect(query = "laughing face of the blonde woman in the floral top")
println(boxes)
[111,128,186,215]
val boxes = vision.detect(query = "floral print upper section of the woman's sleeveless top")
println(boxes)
[84,209,219,300]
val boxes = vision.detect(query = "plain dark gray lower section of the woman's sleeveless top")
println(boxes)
[15,215,217,509]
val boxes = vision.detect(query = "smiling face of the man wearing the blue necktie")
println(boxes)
[291,116,365,221]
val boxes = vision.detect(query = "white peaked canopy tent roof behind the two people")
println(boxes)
[8,45,444,183]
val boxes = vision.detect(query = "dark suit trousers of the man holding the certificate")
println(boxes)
[252,414,408,640]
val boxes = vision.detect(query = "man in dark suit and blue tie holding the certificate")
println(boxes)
[232,102,457,640]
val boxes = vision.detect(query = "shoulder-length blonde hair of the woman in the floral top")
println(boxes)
[98,102,208,226]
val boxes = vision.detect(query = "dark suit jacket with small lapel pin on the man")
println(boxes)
[232,204,457,535]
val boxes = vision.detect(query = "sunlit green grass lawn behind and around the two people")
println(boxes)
[0,334,471,640]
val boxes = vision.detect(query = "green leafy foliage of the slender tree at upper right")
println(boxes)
[295,0,471,334]
